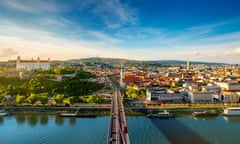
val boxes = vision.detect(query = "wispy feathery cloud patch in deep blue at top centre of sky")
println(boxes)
[78,0,137,28]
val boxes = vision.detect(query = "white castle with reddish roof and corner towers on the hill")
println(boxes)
[16,56,50,70]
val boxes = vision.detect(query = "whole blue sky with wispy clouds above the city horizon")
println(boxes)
[0,0,240,64]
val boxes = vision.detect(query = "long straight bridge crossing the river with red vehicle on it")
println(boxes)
[108,88,130,144]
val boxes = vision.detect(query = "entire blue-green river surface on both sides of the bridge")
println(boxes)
[0,115,240,144]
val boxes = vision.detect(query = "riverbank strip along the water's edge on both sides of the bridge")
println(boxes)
[0,104,240,116]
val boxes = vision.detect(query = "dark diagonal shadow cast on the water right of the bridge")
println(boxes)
[151,118,208,144]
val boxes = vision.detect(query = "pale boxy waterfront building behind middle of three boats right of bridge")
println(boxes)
[188,92,214,103]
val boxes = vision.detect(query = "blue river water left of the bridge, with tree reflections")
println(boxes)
[0,115,108,144]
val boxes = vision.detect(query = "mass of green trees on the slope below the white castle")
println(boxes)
[0,69,104,104]
